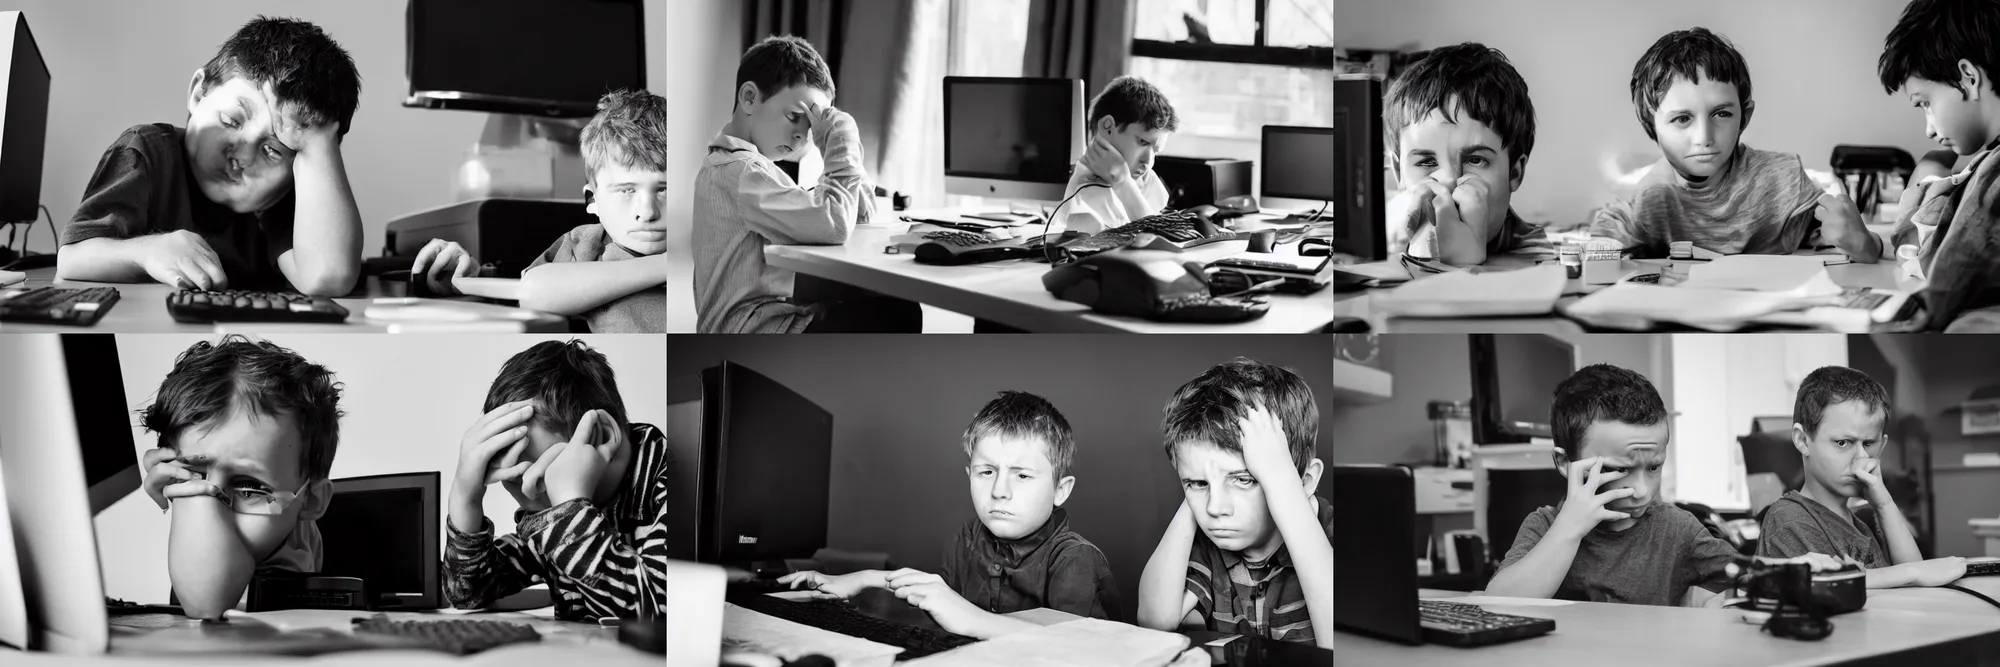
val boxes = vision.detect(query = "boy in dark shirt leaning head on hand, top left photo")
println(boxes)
[56,16,362,296]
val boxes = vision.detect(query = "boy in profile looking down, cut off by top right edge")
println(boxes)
[1876,0,2000,332]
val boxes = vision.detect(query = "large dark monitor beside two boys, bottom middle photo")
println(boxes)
[666,361,834,567]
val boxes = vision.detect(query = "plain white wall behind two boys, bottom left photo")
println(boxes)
[96,334,666,603]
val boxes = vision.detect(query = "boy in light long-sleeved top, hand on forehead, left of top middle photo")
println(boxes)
[694,36,922,334]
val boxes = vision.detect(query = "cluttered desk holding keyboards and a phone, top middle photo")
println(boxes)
[764,212,1334,334]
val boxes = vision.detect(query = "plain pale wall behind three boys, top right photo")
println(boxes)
[1334,0,1938,226]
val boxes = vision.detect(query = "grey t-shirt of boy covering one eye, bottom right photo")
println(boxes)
[1500,503,1736,607]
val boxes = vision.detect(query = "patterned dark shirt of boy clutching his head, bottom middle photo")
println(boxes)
[1186,495,1334,643]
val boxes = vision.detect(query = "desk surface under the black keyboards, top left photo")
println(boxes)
[0,268,570,334]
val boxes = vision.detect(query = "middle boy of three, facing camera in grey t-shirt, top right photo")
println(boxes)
[1590,28,1884,264]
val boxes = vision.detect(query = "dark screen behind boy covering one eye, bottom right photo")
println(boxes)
[1468,334,1576,445]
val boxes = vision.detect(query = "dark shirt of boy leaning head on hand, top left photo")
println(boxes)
[62,124,296,292]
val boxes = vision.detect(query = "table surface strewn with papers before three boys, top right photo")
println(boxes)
[1334,258,1918,334]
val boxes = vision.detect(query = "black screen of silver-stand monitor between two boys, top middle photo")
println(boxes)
[944,78,1078,184]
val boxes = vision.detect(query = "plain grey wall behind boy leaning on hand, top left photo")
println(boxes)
[8,0,684,258]
